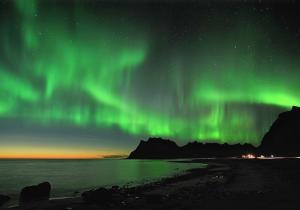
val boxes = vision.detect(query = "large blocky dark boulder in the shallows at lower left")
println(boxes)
[19,182,51,203]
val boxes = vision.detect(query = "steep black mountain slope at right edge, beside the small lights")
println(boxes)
[260,106,300,156]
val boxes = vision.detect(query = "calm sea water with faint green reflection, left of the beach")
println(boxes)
[0,159,205,196]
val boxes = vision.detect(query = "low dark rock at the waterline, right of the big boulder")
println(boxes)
[81,187,113,204]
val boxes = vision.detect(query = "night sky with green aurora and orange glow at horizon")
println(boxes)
[0,0,300,158]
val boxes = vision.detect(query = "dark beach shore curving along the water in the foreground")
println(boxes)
[2,159,300,210]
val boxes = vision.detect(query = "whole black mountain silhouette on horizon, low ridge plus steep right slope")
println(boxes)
[128,106,300,159]
